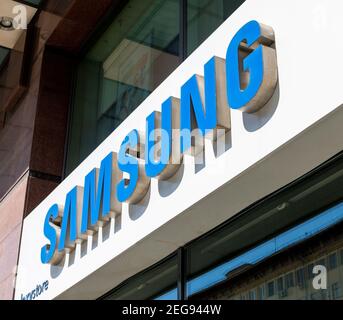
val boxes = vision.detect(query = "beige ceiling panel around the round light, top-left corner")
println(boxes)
[0,0,37,49]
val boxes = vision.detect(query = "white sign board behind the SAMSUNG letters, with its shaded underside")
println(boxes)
[15,0,343,299]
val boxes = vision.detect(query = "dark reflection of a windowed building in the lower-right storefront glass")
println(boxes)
[195,221,343,300]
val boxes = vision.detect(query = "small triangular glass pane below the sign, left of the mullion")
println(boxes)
[104,256,178,300]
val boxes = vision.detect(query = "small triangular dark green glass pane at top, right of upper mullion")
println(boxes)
[187,0,245,54]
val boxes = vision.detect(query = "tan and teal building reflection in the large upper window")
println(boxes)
[99,39,179,130]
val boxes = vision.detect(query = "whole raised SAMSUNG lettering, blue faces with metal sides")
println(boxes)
[41,21,278,265]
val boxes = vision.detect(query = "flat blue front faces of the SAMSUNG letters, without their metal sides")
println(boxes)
[41,21,272,263]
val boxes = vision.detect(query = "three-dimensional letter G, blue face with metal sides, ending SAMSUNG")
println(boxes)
[226,21,278,113]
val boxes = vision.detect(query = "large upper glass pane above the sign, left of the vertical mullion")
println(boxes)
[66,0,180,173]
